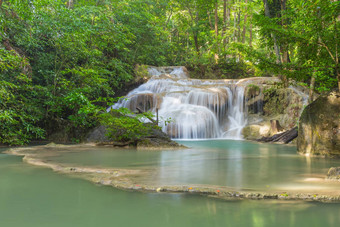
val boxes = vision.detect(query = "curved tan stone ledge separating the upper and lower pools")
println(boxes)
[6,145,340,202]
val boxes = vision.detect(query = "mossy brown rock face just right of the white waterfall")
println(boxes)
[242,84,308,140]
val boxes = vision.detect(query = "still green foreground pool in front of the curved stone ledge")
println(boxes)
[0,153,340,227]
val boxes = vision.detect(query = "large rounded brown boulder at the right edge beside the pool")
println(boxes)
[297,92,340,157]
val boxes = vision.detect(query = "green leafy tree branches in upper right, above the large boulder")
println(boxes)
[248,0,340,92]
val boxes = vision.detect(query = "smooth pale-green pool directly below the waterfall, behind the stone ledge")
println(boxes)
[49,140,340,190]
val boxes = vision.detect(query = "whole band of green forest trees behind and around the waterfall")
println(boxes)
[0,0,340,145]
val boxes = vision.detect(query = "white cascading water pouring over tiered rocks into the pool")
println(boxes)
[111,67,251,139]
